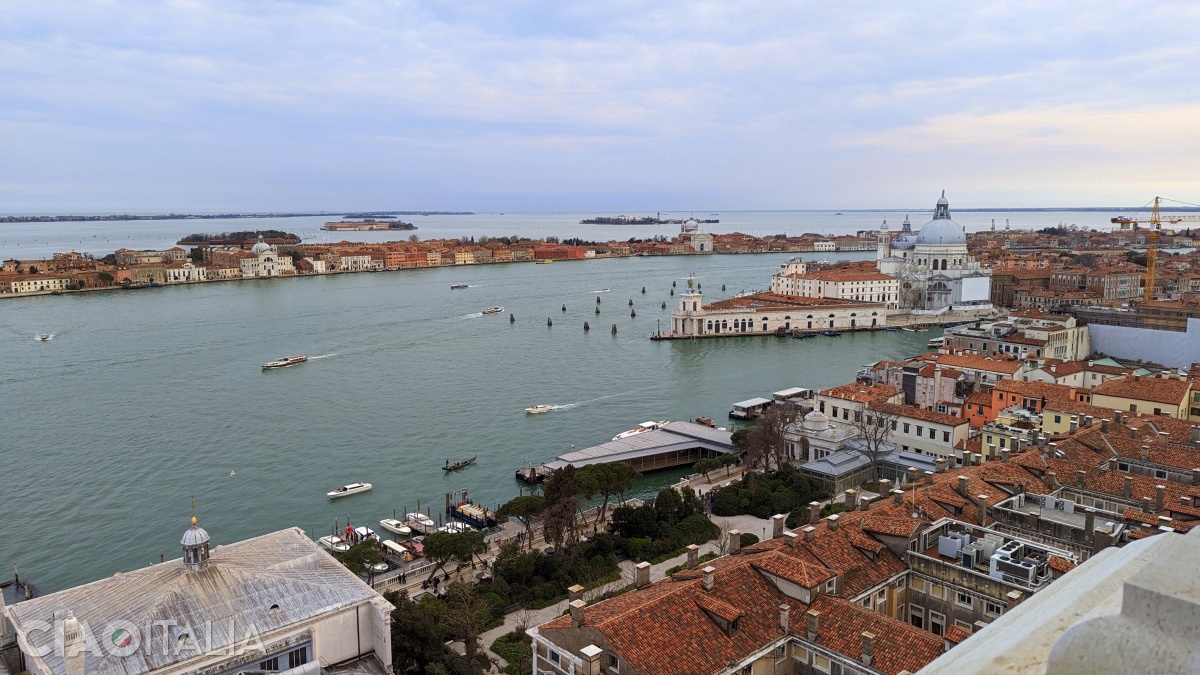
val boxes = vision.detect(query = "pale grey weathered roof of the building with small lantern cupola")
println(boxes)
[8,528,378,675]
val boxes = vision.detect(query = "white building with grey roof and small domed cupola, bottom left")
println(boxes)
[0,518,395,675]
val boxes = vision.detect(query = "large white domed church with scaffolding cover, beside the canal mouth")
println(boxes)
[877,191,991,311]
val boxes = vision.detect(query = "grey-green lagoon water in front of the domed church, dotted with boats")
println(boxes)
[0,247,930,592]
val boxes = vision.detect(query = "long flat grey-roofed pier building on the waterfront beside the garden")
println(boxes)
[516,422,738,484]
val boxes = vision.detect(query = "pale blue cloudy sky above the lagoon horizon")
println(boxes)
[0,0,1200,213]
